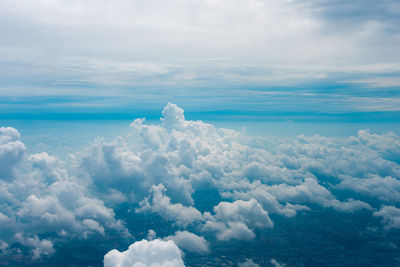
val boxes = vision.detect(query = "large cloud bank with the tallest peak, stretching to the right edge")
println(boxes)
[78,104,400,230]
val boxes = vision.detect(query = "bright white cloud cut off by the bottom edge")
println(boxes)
[104,239,185,267]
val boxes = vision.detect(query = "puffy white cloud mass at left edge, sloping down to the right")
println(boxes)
[0,128,129,259]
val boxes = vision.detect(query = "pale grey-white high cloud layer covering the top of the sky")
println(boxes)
[0,0,400,104]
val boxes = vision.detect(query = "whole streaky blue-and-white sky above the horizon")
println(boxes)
[0,0,400,121]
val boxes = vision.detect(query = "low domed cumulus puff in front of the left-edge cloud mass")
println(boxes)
[16,181,124,236]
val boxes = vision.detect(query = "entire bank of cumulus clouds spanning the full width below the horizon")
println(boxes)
[0,104,400,264]
